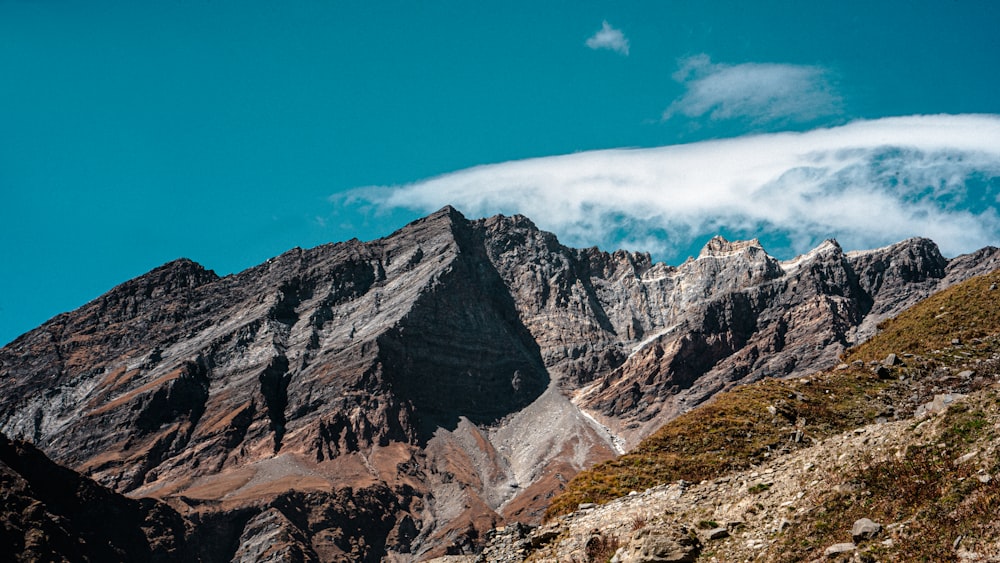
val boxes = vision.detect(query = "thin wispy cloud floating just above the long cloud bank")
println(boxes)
[663,54,841,123]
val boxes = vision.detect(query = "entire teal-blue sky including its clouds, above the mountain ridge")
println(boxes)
[0,0,1000,343]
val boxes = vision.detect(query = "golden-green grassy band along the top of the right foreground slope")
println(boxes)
[546,272,1000,518]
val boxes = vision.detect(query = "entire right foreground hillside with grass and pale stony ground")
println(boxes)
[476,271,1000,563]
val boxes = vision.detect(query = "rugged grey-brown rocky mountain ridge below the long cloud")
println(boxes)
[0,207,1000,561]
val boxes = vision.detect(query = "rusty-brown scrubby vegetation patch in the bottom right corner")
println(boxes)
[776,390,1000,562]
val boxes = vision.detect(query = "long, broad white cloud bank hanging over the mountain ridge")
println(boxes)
[339,115,1000,261]
